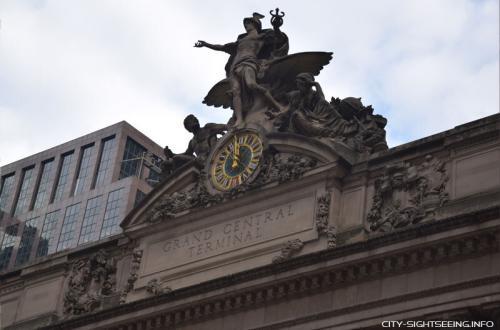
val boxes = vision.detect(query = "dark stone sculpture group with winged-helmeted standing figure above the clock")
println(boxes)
[162,9,387,177]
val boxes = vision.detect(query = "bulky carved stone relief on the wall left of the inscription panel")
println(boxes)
[64,250,116,317]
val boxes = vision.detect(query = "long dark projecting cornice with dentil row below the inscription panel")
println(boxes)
[47,206,500,329]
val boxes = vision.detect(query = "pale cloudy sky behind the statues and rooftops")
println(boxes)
[0,0,499,166]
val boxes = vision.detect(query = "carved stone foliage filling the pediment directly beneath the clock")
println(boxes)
[147,154,317,223]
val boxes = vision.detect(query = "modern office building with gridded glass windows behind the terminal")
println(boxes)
[0,121,162,272]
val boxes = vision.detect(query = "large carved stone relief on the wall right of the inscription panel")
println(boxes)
[367,155,449,232]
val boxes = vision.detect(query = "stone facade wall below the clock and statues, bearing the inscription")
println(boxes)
[0,115,500,329]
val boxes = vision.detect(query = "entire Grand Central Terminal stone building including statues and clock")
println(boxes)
[0,9,500,330]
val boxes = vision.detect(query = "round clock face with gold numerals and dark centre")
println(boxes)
[210,131,263,191]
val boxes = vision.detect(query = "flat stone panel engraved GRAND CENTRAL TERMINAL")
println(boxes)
[143,197,315,275]
